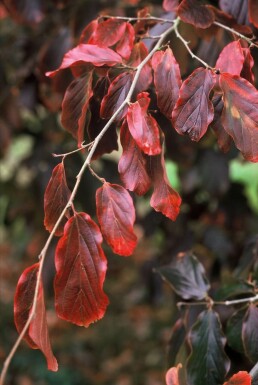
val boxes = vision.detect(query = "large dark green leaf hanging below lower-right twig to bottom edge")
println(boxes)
[186,310,230,385]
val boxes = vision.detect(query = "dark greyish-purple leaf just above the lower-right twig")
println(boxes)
[157,253,210,300]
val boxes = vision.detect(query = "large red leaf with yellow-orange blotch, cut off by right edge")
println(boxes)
[220,73,258,162]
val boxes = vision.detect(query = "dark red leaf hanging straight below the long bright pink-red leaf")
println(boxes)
[61,71,93,147]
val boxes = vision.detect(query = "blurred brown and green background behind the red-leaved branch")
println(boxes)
[0,0,258,385]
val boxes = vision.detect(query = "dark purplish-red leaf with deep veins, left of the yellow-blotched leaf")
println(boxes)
[172,68,215,141]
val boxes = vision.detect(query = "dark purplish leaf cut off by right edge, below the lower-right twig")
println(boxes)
[242,304,258,362]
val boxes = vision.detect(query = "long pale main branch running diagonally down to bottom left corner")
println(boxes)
[0,18,180,385]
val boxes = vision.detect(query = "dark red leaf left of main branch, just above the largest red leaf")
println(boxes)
[44,162,71,236]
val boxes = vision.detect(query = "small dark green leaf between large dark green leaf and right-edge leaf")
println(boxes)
[226,306,247,353]
